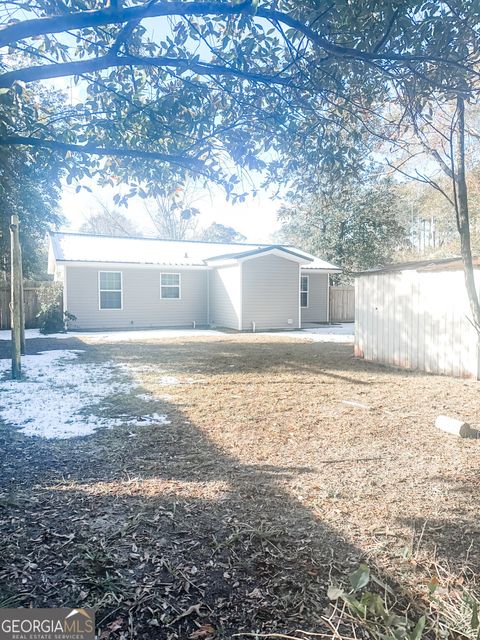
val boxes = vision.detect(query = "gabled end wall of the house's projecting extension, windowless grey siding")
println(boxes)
[242,255,300,330]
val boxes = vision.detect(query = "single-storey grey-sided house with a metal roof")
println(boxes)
[49,233,340,331]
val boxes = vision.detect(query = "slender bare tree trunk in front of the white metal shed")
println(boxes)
[453,96,480,335]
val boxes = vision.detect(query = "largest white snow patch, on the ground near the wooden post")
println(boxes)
[0,350,169,439]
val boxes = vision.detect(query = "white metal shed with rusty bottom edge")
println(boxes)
[355,259,480,379]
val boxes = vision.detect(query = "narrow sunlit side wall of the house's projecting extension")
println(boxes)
[210,264,241,329]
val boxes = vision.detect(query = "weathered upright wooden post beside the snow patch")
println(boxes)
[10,216,22,380]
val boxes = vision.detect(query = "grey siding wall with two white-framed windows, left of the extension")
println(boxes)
[65,265,207,329]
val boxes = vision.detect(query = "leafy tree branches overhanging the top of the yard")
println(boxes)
[0,0,479,199]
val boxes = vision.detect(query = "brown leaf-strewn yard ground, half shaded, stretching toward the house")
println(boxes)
[0,335,480,639]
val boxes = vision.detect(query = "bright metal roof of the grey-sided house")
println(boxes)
[50,232,340,271]
